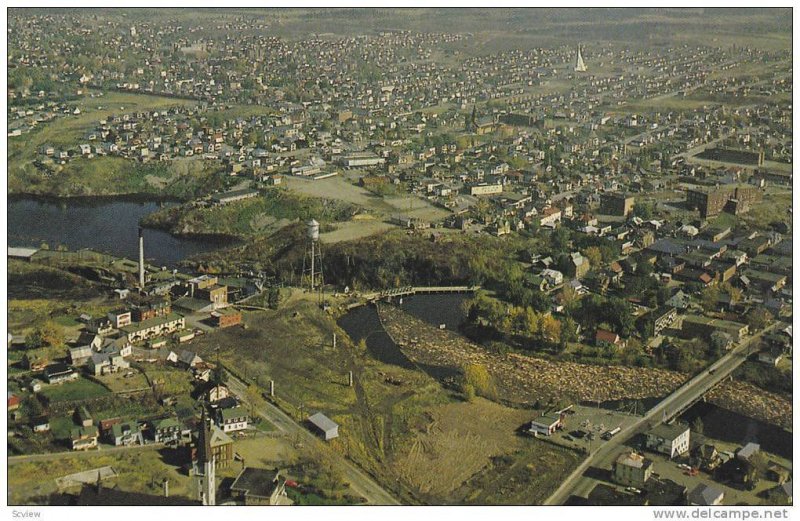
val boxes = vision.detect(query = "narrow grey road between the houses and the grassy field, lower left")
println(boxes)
[228,375,400,505]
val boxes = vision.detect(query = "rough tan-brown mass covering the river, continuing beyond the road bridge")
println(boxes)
[378,305,792,429]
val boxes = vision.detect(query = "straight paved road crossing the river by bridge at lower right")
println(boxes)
[544,322,778,505]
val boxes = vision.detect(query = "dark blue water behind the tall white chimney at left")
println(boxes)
[7,198,230,267]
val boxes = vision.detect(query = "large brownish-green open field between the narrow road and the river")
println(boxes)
[186,299,578,504]
